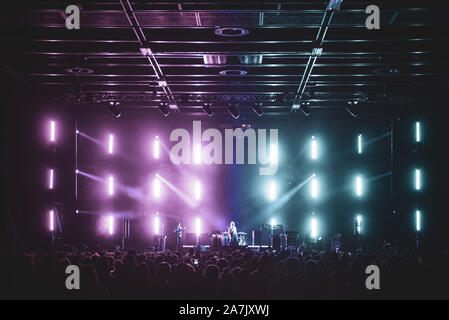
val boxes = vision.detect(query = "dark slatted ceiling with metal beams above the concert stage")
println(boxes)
[1,0,448,113]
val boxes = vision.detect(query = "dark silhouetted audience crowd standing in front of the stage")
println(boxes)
[0,247,449,299]
